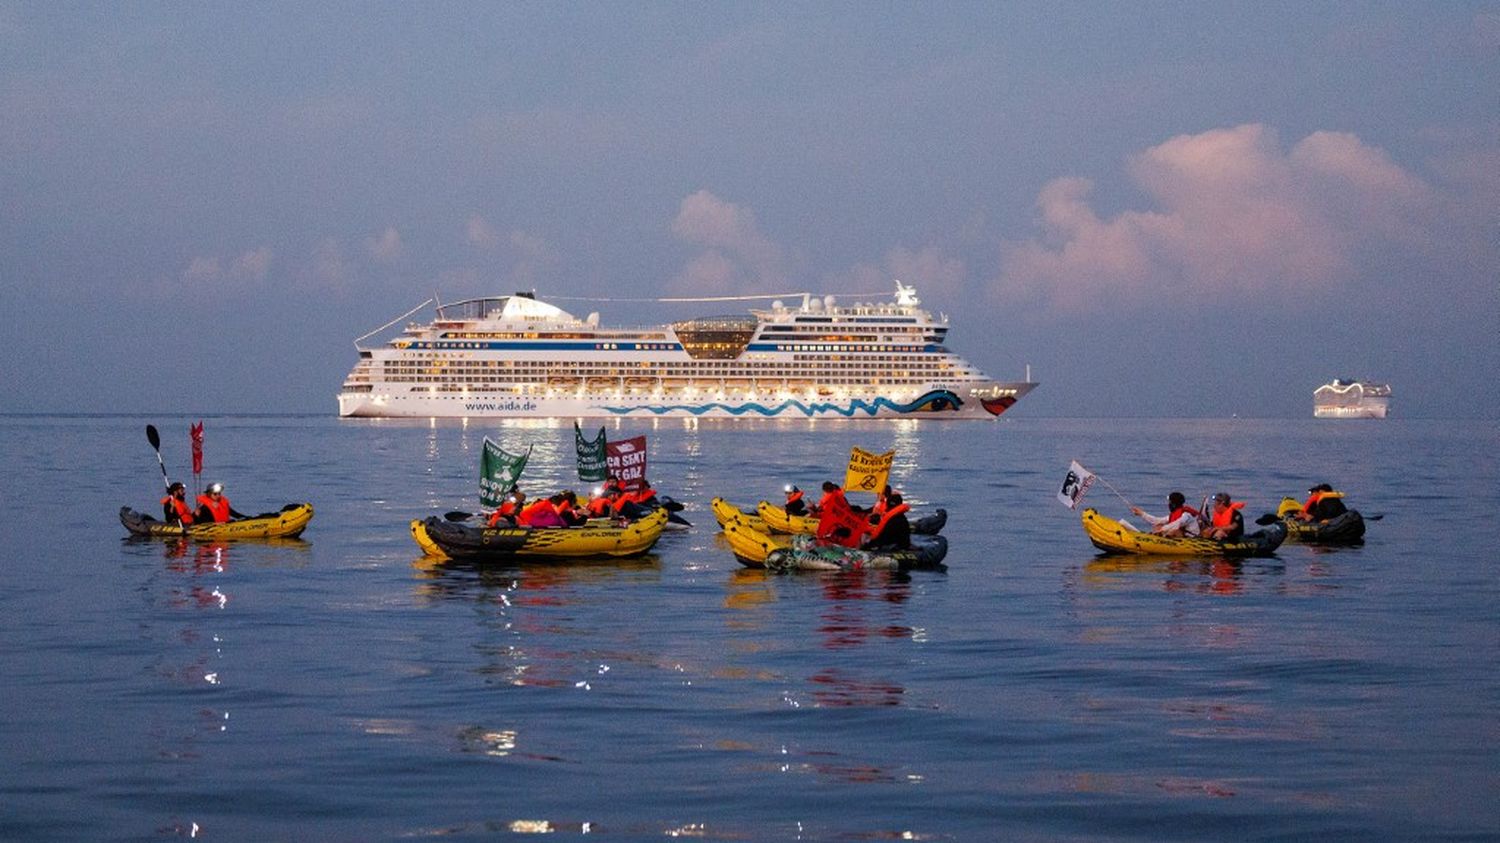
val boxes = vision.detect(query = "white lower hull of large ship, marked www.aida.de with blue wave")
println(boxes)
[339,383,1037,419]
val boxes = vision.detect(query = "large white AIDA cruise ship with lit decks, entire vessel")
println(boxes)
[339,282,1037,419]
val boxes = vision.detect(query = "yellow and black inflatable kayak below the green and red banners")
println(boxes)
[411,509,668,561]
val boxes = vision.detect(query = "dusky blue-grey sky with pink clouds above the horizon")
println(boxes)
[0,0,1500,419]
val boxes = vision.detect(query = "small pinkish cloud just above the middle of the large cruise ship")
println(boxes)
[672,191,786,291]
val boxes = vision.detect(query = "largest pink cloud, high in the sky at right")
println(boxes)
[992,125,1433,308]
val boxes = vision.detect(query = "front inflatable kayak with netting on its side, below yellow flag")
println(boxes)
[725,521,948,572]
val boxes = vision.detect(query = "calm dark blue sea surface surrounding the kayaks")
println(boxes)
[0,408,1500,840]
